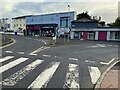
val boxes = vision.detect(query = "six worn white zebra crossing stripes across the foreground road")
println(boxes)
[0,56,101,89]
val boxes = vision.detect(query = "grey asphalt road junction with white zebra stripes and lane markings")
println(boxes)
[0,35,118,90]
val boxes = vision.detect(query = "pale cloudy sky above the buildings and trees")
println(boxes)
[0,0,120,23]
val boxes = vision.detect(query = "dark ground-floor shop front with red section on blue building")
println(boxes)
[26,24,57,37]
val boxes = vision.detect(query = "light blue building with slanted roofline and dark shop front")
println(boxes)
[26,11,76,36]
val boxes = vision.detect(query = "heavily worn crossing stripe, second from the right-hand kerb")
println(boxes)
[63,64,80,90]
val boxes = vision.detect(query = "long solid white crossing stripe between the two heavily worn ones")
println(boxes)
[28,62,60,88]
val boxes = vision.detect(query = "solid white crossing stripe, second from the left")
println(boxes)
[0,57,28,73]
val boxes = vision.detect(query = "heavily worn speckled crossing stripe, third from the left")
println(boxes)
[0,60,43,86]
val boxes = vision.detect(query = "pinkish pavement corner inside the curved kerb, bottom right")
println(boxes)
[100,62,120,90]
